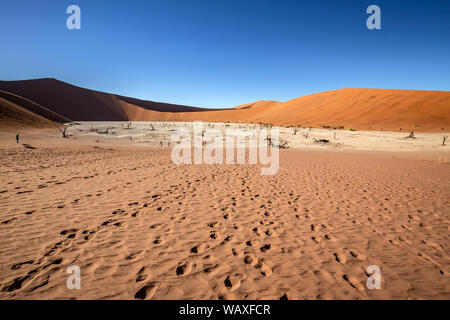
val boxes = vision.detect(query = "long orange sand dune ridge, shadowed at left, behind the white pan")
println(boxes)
[0,79,450,131]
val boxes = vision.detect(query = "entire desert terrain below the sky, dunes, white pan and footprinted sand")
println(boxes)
[0,79,450,299]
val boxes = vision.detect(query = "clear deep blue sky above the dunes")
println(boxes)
[0,0,450,107]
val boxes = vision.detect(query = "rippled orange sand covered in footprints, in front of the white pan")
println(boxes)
[0,130,450,299]
